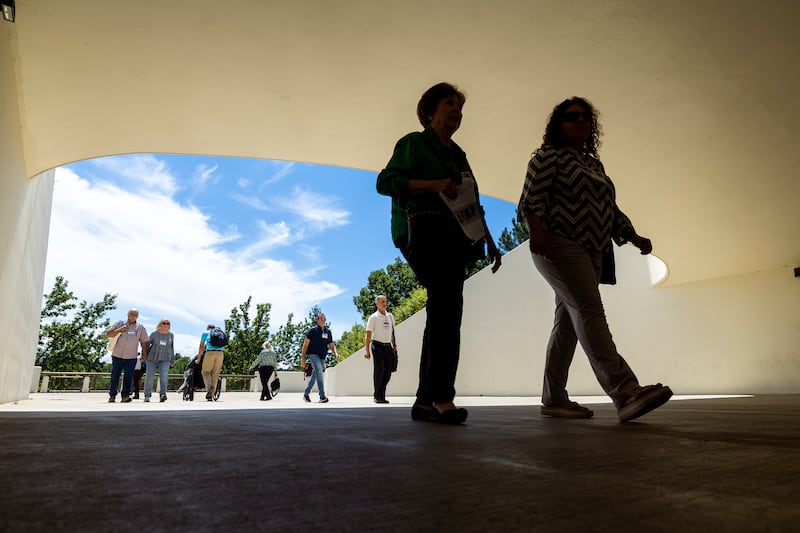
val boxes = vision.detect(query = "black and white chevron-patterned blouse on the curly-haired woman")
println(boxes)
[517,145,635,252]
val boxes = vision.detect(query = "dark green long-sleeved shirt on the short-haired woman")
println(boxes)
[376,127,472,242]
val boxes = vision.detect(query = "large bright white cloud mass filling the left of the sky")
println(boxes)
[45,166,348,355]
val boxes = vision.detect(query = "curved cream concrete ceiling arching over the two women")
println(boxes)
[6,0,800,284]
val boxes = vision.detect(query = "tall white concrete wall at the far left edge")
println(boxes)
[0,23,53,403]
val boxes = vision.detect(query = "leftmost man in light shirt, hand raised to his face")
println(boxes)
[106,309,148,403]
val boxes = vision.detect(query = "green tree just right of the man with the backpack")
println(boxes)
[222,296,272,374]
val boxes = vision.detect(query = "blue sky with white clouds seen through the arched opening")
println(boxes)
[45,152,514,355]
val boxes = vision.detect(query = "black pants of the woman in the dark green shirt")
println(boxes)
[404,214,469,405]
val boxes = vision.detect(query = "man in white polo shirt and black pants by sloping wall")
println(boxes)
[364,294,397,403]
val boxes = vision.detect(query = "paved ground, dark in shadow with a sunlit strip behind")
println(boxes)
[0,393,800,532]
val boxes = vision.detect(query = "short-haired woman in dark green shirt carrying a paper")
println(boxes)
[376,83,500,424]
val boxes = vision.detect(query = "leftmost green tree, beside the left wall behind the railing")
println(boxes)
[36,276,117,372]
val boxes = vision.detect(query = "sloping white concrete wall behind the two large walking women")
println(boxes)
[329,241,800,396]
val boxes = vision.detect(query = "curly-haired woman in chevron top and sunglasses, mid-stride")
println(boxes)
[517,97,672,422]
